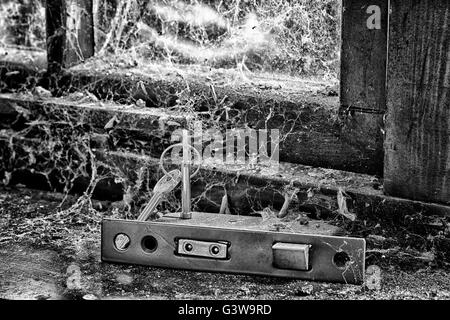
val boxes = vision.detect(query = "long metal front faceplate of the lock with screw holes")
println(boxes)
[102,213,365,284]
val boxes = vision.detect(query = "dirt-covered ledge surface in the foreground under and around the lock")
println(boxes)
[0,189,450,300]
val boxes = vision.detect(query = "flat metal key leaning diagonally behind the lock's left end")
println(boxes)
[137,170,181,221]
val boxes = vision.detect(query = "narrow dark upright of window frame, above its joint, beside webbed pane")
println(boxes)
[341,0,388,113]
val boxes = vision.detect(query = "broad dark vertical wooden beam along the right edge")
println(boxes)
[384,0,450,204]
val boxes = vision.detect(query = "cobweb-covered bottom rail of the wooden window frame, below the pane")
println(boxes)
[57,64,383,175]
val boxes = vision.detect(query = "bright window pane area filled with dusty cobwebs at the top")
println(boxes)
[98,0,340,77]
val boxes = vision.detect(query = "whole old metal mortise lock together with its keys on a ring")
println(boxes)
[101,131,366,284]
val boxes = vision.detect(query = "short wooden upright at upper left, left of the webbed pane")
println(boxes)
[46,0,94,72]
